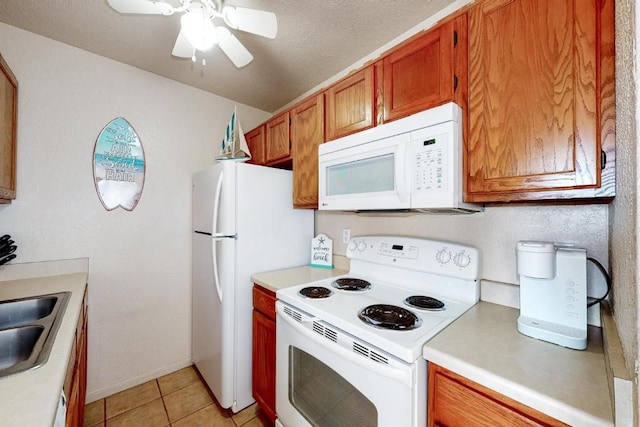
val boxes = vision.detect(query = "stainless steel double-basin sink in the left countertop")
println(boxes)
[0,292,71,378]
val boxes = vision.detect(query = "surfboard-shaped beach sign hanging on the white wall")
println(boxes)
[93,117,145,211]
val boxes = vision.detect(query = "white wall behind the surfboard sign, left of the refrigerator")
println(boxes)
[0,24,270,401]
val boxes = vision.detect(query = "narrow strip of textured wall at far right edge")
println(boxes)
[609,0,640,425]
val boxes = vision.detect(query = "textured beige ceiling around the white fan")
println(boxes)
[0,0,454,112]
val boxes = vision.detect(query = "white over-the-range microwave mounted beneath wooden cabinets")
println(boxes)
[318,102,483,213]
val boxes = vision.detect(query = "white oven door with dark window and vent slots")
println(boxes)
[276,301,427,427]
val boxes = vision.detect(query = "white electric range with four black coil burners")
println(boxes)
[276,236,480,427]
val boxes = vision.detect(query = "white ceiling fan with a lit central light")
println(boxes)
[107,0,278,68]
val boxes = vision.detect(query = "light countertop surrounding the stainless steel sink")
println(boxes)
[0,263,87,427]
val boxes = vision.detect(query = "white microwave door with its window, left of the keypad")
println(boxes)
[319,134,410,210]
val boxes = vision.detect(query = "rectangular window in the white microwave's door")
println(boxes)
[326,153,395,196]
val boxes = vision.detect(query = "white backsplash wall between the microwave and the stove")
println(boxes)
[316,204,609,296]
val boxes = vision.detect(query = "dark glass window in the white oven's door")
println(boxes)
[289,346,378,427]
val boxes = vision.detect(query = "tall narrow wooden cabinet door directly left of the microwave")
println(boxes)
[291,94,324,209]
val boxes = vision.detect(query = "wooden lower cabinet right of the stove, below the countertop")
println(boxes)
[427,363,566,427]
